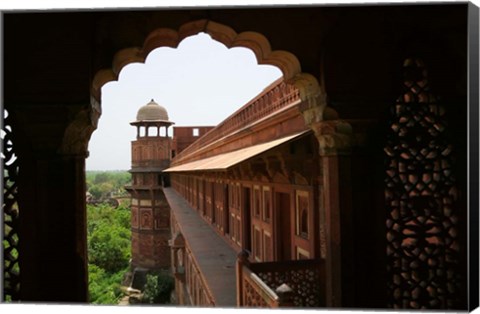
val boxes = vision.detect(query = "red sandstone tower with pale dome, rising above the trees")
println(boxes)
[126,99,174,270]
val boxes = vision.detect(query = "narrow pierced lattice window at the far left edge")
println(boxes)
[1,110,20,301]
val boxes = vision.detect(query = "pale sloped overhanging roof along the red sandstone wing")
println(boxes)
[163,130,309,172]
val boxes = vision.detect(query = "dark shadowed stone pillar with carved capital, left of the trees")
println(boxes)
[12,102,98,303]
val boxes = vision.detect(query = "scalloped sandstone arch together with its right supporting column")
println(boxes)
[86,20,353,306]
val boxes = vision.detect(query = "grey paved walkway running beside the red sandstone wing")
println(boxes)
[163,188,237,307]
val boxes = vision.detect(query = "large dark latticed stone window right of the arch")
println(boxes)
[385,59,460,309]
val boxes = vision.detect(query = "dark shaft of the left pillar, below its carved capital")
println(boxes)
[19,152,88,302]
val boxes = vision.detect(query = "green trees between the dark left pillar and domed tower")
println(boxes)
[86,171,131,304]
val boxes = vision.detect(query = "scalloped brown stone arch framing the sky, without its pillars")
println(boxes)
[91,20,326,121]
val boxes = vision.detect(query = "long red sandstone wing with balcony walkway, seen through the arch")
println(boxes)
[164,79,326,307]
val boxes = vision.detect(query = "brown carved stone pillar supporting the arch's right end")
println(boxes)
[310,120,353,307]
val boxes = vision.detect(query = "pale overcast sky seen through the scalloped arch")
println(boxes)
[86,34,282,170]
